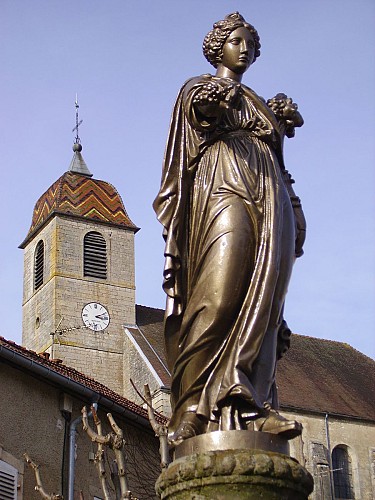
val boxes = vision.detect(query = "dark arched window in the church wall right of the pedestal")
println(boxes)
[332,445,354,500]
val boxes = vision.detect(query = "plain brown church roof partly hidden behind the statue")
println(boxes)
[136,305,375,422]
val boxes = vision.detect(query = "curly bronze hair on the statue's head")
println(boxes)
[202,12,260,68]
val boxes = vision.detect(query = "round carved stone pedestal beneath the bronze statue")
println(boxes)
[156,431,313,500]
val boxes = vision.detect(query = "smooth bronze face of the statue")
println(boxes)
[220,28,255,75]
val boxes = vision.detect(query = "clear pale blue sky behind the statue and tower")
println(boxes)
[0,0,375,357]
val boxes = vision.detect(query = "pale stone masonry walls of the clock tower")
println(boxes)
[23,217,135,393]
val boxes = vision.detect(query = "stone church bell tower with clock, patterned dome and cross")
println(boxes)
[20,109,138,394]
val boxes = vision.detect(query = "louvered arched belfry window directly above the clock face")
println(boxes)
[83,231,107,279]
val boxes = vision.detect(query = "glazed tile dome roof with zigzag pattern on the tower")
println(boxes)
[20,171,138,248]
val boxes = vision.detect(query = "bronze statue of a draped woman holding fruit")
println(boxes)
[154,12,305,443]
